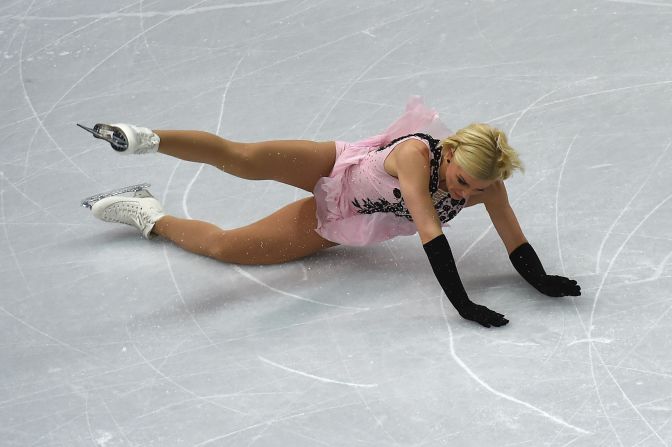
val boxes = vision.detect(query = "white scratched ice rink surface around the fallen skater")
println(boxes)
[0,0,672,447]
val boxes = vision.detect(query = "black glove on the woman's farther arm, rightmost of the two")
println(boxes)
[509,242,581,297]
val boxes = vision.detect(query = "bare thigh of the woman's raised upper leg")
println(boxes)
[235,140,336,192]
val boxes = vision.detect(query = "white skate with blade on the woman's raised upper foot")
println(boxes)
[77,123,161,154]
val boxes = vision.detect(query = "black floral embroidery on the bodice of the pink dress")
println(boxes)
[352,133,466,223]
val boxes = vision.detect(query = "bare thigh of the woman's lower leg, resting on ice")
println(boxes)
[220,197,338,264]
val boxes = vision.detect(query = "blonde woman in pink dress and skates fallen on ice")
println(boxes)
[81,98,581,327]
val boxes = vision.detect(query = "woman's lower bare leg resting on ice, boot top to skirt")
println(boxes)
[152,197,338,265]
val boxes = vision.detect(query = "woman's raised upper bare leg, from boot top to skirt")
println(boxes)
[154,130,336,192]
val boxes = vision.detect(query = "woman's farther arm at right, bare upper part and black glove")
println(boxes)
[483,181,581,297]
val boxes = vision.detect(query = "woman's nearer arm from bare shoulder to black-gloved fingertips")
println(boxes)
[395,140,508,327]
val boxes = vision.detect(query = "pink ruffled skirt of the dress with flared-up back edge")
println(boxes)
[313,96,451,246]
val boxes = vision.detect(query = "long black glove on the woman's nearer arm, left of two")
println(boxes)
[423,234,509,327]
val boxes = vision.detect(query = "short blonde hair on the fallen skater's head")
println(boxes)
[441,123,523,181]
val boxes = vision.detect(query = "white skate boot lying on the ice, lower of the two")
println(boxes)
[91,189,166,239]
